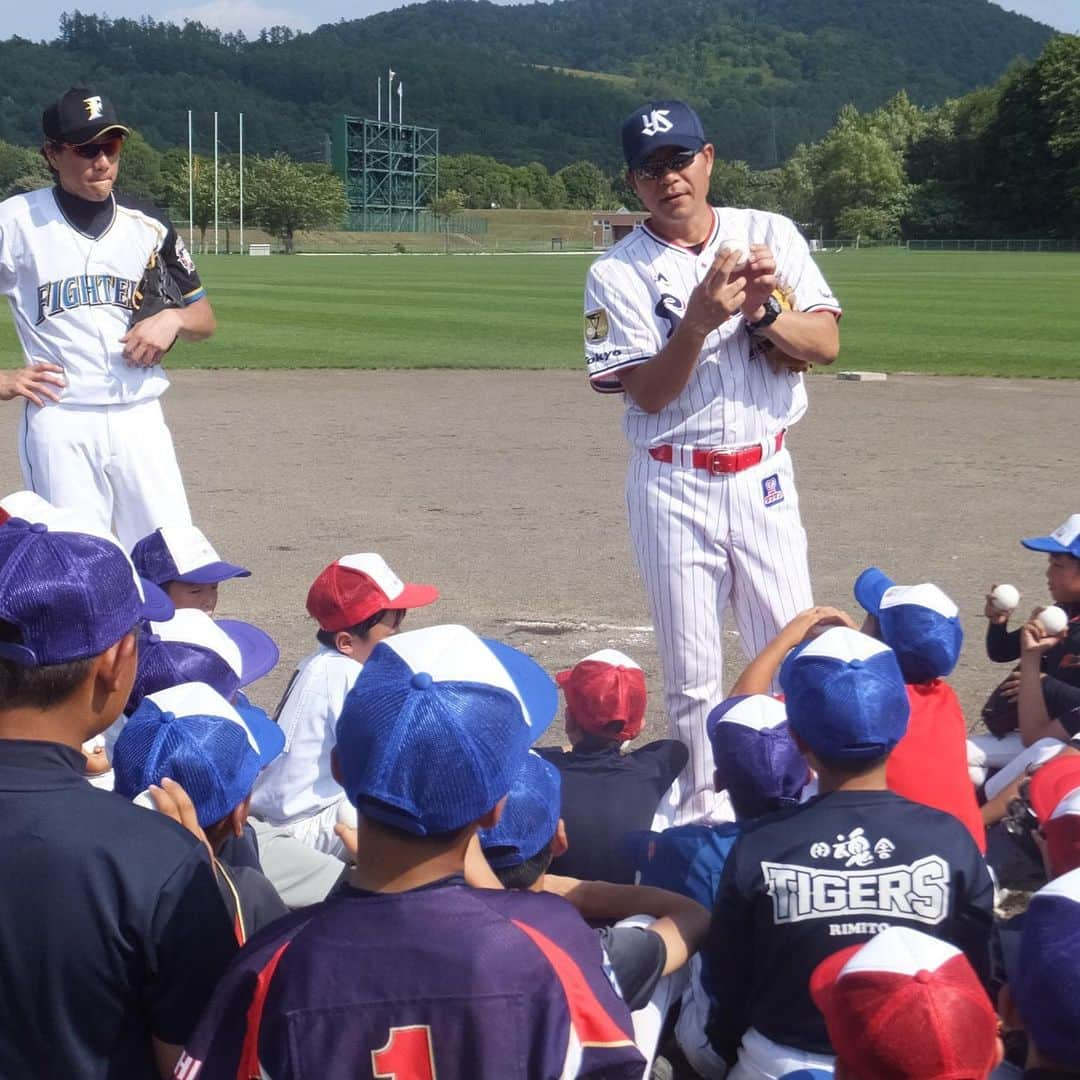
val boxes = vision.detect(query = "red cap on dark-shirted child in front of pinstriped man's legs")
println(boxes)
[555,649,647,742]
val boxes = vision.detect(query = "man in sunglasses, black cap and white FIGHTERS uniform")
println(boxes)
[0,87,215,548]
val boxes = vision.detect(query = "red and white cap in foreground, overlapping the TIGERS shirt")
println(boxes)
[810,927,998,1080]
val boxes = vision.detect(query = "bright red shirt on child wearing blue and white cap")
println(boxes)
[886,679,986,854]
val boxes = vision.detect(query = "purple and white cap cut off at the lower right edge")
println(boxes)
[1009,869,1080,1068]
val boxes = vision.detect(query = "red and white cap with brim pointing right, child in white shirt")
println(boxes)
[308,552,438,632]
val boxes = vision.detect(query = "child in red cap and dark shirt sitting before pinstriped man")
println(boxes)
[538,649,689,885]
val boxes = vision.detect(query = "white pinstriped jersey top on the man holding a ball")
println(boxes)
[585,207,840,447]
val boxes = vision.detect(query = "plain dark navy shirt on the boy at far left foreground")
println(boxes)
[0,740,237,1080]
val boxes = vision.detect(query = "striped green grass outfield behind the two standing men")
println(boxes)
[0,248,1080,378]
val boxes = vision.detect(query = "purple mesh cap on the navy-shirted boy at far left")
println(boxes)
[0,517,154,667]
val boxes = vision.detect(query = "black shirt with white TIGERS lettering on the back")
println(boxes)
[702,791,994,1054]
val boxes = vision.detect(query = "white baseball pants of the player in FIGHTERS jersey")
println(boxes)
[18,399,191,551]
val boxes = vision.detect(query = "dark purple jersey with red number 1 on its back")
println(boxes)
[176,877,642,1080]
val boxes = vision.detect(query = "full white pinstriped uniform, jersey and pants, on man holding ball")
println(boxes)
[585,207,840,824]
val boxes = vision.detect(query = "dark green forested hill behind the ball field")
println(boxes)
[0,0,1053,168]
